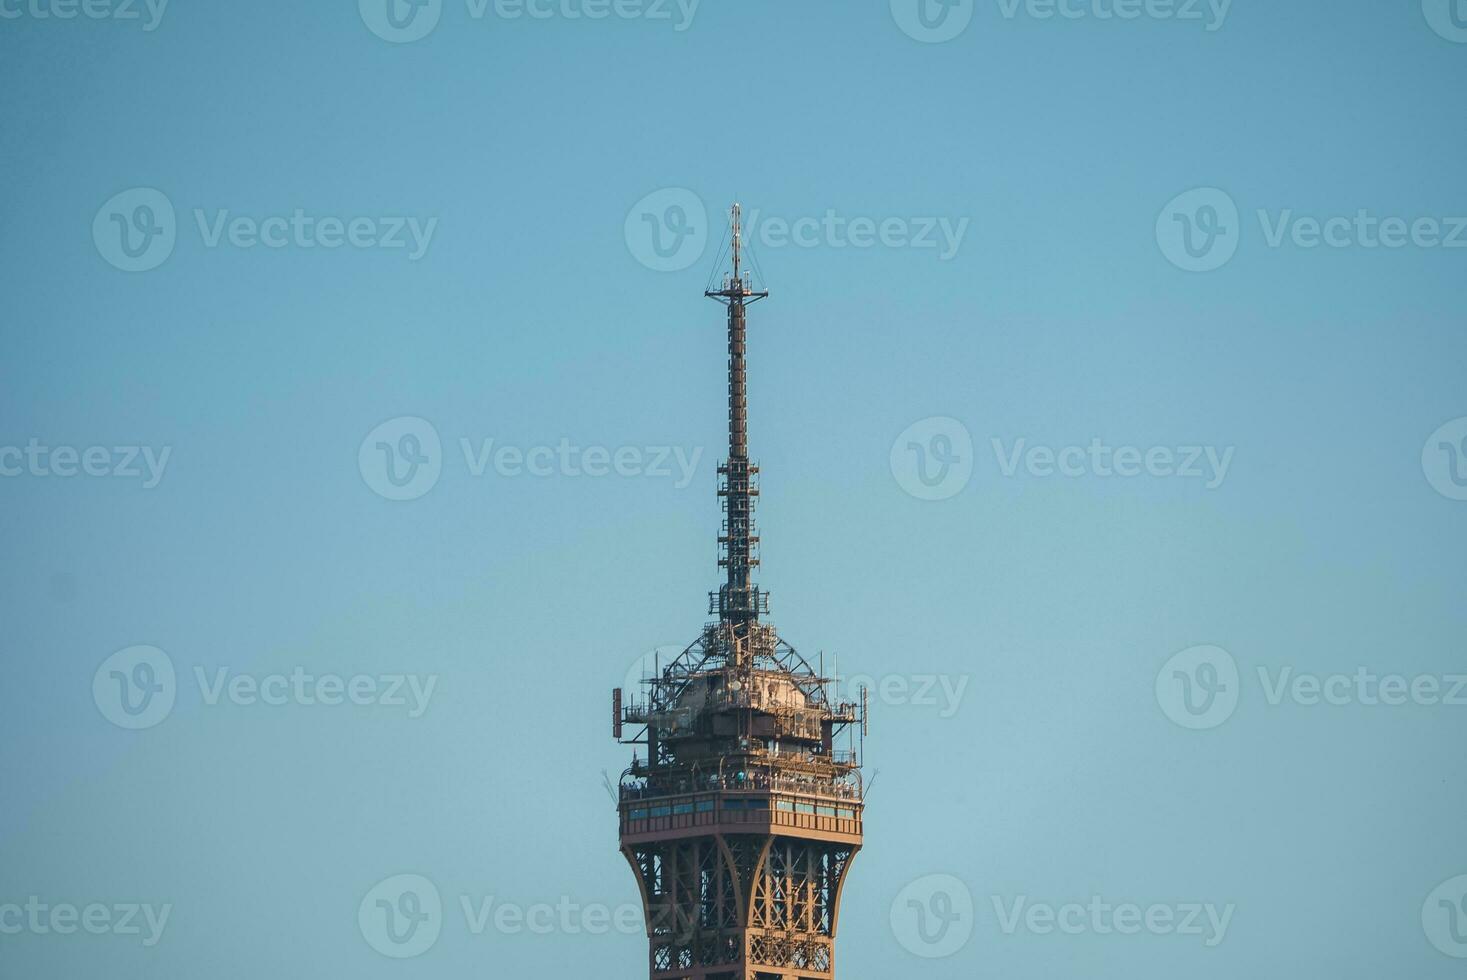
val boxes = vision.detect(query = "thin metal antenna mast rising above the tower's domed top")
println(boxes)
[703,202,769,628]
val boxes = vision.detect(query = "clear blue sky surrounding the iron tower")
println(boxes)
[0,0,1467,980]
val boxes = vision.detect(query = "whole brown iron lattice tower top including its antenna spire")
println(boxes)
[612,204,866,980]
